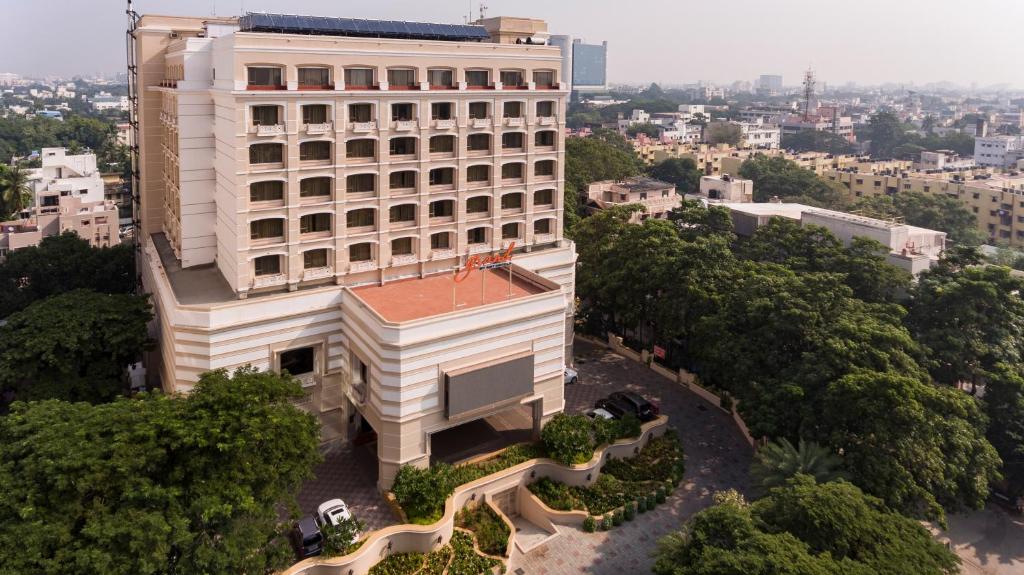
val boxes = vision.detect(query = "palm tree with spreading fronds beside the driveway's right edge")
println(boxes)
[751,438,845,489]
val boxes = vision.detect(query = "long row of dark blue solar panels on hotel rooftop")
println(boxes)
[239,12,489,42]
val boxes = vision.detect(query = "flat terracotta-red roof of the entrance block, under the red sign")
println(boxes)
[352,269,548,322]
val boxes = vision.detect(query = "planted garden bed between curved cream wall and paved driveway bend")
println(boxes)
[527,431,683,528]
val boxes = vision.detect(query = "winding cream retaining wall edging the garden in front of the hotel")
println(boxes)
[283,415,669,575]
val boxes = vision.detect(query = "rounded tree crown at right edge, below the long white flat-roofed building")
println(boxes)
[906,264,1024,385]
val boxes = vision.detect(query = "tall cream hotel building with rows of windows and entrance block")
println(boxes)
[135,14,575,488]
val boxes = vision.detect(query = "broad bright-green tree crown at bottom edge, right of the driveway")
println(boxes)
[653,475,958,575]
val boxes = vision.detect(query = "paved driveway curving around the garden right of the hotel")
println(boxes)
[511,340,753,575]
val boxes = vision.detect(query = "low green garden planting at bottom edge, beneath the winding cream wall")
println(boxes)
[370,530,501,575]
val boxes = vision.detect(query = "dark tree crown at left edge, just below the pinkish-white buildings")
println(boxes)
[0,232,135,318]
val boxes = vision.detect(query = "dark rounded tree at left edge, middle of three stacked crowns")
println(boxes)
[0,290,153,403]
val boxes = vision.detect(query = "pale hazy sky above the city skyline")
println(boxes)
[0,0,1024,87]
